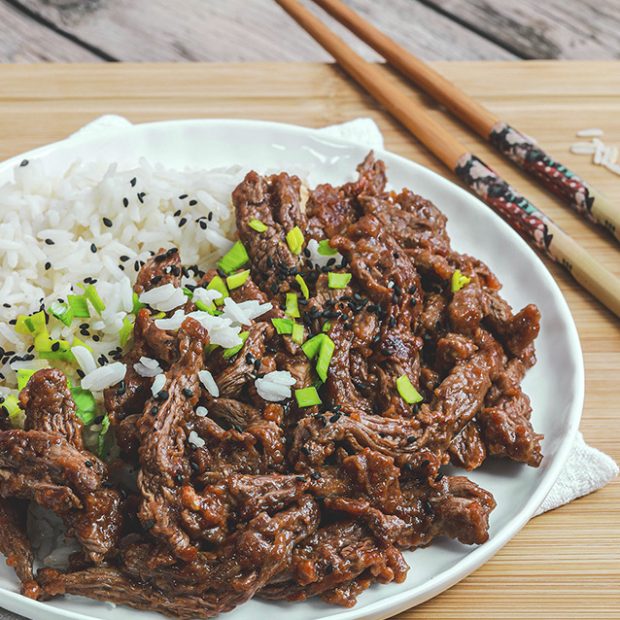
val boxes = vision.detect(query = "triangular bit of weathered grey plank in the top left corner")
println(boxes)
[0,4,100,63]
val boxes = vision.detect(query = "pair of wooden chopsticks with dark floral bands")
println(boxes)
[276,0,620,317]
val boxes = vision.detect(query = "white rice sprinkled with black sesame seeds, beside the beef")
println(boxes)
[0,155,247,393]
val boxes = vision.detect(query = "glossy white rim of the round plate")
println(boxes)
[0,118,585,620]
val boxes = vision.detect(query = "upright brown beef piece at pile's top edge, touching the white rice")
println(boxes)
[233,172,307,296]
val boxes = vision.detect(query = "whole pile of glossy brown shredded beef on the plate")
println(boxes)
[0,153,542,619]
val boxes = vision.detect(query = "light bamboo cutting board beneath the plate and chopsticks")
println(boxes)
[0,61,620,620]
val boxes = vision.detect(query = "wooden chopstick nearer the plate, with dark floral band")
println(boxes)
[276,0,620,317]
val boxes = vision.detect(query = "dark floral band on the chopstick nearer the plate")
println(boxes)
[455,153,554,258]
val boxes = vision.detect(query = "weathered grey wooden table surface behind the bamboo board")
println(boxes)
[0,0,620,62]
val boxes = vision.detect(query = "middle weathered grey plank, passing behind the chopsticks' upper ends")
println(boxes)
[5,0,514,62]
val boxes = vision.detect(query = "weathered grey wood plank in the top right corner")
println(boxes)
[419,0,620,60]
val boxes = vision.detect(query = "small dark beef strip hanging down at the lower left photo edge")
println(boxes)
[0,499,39,599]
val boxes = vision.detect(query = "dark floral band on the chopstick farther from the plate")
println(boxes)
[489,121,596,222]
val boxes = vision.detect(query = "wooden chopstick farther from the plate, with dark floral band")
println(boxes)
[314,0,620,241]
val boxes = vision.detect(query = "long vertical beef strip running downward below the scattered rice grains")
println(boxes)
[138,318,209,560]
